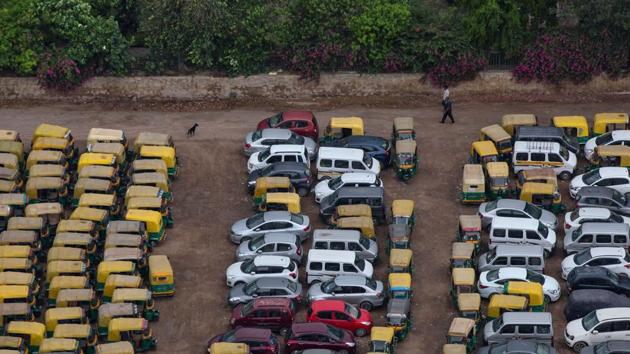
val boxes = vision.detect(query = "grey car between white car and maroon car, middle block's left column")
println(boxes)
[228,277,302,306]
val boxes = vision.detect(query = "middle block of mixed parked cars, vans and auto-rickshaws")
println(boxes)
[208,112,417,354]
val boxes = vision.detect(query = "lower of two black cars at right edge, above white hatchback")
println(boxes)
[564,290,630,322]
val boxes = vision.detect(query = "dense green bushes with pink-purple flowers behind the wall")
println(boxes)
[0,0,630,90]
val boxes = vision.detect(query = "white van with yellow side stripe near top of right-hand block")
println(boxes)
[512,141,577,180]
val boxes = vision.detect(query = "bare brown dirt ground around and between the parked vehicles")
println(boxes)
[0,100,630,354]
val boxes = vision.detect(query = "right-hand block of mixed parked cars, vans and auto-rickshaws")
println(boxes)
[444,114,630,353]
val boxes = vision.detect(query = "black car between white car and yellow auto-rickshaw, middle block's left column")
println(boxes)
[247,162,313,197]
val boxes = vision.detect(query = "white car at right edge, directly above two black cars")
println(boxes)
[562,247,630,279]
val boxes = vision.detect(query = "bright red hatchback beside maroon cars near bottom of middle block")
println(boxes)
[306,300,373,337]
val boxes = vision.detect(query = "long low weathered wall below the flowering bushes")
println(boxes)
[0,71,630,101]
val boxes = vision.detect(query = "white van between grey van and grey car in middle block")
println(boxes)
[306,249,374,284]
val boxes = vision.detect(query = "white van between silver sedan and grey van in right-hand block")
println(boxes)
[490,216,556,255]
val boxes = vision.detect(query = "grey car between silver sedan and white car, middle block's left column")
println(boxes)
[236,232,304,263]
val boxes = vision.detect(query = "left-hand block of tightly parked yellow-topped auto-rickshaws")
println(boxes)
[0,124,177,354]
